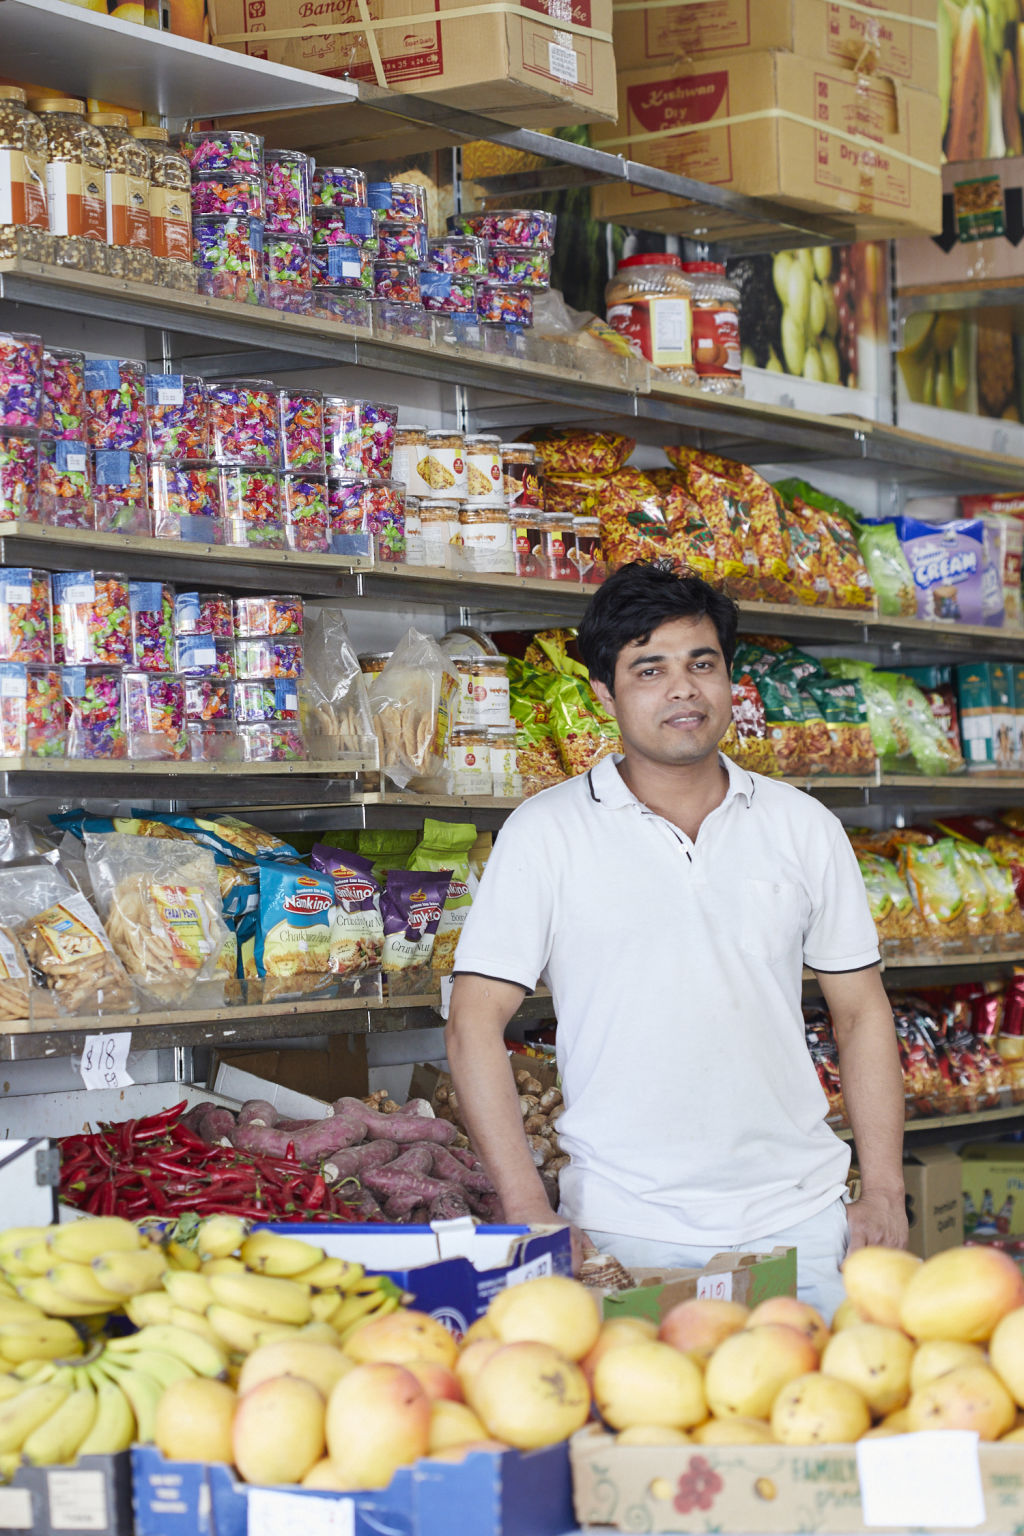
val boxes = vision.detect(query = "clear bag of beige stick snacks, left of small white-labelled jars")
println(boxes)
[370,630,459,790]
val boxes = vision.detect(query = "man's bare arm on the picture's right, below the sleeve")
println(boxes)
[815,966,907,1249]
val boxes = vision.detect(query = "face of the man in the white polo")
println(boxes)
[594,617,732,765]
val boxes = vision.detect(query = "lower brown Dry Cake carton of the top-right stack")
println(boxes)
[591,52,941,240]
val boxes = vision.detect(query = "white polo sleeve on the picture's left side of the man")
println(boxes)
[454,806,554,992]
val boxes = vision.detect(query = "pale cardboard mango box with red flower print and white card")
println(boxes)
[570,1425,1024,1536]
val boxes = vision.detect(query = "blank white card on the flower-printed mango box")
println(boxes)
[857,1430,986,1531]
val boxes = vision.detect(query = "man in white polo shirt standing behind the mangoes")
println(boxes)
[447,565,907,1315]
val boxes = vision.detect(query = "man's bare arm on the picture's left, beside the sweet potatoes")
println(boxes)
[445,972,553,1223]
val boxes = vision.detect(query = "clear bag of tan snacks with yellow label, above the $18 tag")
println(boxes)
[0,865,137,1018]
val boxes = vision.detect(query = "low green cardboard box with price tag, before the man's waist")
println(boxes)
[605,1247,797,1322]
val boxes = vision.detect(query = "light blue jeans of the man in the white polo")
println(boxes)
[586,1200,849,1322]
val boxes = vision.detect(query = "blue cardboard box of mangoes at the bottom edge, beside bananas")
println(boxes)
[133,1444,573,1536]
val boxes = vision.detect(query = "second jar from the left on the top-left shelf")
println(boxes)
[29,97,109,272]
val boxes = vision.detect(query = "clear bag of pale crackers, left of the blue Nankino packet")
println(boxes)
[84,833,227,1008]
